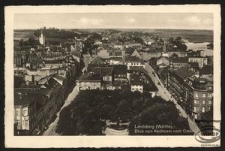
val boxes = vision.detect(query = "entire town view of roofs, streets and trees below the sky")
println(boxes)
[14,27,213,136]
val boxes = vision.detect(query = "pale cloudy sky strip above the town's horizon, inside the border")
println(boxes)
[14,13,213,30]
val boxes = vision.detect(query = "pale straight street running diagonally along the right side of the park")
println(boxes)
[145,63,200,134]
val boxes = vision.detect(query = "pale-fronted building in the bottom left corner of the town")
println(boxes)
[14,92,46,135]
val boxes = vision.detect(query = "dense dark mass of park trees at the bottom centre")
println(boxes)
[57,90,186,135]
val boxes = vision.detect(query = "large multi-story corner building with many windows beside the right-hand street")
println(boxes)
[167,68,213,119]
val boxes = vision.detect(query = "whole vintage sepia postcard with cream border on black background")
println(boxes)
[5,5,221,148]
